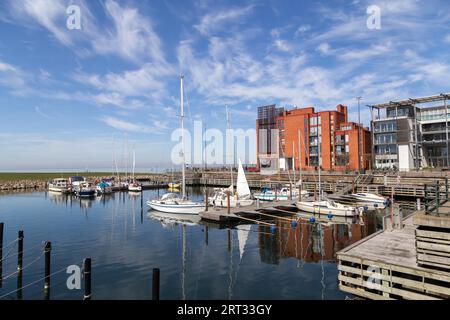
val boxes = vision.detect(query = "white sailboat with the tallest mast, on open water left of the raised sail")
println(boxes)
[147,76,205,214]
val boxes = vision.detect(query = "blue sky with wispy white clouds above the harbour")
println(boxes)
[0,0,450,171]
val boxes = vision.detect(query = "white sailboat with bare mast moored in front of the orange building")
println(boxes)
[296,130,359,217]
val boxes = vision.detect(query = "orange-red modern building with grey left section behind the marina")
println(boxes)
[256,105,372,174]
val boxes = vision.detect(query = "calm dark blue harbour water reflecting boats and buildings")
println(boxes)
[0,189,380,299]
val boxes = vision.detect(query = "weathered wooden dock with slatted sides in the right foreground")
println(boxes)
[337,204,450,300]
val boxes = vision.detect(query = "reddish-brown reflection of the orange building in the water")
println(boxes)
[259,220,368,264]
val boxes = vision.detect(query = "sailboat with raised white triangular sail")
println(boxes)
[209,159,254,208]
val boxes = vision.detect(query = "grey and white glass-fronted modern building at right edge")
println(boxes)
[369,94,450,171]
